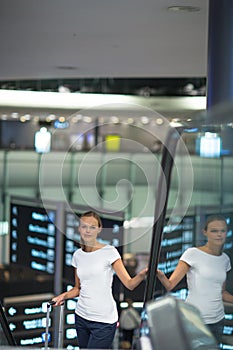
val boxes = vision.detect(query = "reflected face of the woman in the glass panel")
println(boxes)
[203,220,227,246]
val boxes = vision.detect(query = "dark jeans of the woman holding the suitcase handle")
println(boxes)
[75,314,117,349]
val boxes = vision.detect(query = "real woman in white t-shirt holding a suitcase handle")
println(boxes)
[53,211,147,349]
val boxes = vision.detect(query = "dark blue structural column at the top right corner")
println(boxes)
[207,0,233,109]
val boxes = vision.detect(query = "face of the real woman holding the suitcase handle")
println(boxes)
[79,216,101,245]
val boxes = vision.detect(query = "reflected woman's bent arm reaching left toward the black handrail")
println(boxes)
[157,260,190,292]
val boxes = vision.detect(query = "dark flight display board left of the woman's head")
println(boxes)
[10,202,56,274]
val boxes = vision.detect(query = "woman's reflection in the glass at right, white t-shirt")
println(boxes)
[157,215,233,343]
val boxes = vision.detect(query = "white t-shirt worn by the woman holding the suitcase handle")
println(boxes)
[72,245,121,323]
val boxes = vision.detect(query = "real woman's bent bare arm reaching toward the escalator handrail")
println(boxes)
[112,259,148,290]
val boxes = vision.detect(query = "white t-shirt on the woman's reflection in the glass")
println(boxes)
[180,247,231,324]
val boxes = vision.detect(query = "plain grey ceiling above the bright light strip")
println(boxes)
[0,0,208,120]
